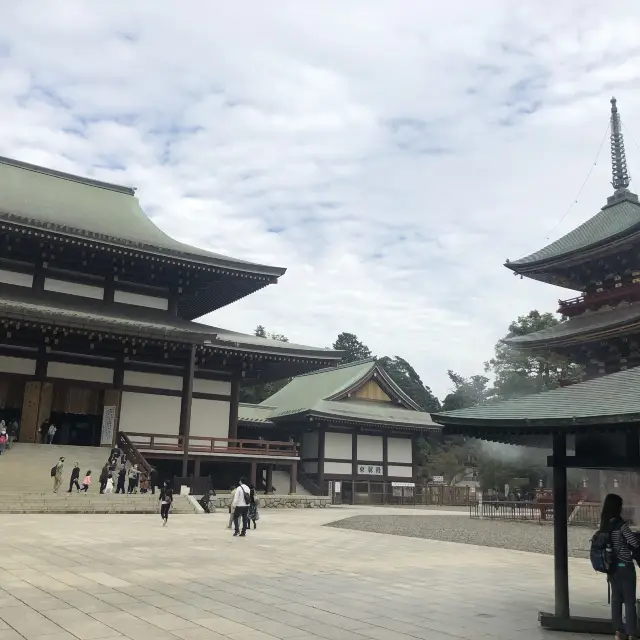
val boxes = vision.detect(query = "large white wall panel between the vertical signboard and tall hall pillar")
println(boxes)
[120,391,180,436]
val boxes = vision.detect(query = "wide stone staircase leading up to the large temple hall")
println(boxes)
[0,443,197,513]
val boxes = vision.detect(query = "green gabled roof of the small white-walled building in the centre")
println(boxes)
[238,358,439,430]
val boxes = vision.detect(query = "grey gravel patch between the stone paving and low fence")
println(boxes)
[327,515,593,558]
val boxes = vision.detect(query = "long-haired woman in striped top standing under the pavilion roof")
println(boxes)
[596,493,640,640]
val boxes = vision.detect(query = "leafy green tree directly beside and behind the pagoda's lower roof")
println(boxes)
[484,310,583,400]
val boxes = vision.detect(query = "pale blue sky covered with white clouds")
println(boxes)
[0,0,640,398]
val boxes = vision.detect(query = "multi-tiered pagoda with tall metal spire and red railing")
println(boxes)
[504,98,640,379]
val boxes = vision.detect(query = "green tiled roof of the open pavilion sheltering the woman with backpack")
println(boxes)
[431,367,640,428]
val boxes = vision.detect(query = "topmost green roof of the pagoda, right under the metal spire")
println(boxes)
[506,194,640,271]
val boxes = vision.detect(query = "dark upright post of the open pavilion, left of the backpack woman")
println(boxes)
[553,434,569,618]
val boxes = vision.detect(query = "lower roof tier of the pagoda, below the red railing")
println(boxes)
[502,302,640,350]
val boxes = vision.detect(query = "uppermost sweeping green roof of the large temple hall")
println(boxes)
[0,156,286,278]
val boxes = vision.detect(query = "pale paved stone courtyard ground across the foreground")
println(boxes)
[0,508,607,640]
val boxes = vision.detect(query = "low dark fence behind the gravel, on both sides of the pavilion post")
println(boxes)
[469,500,601,526]
